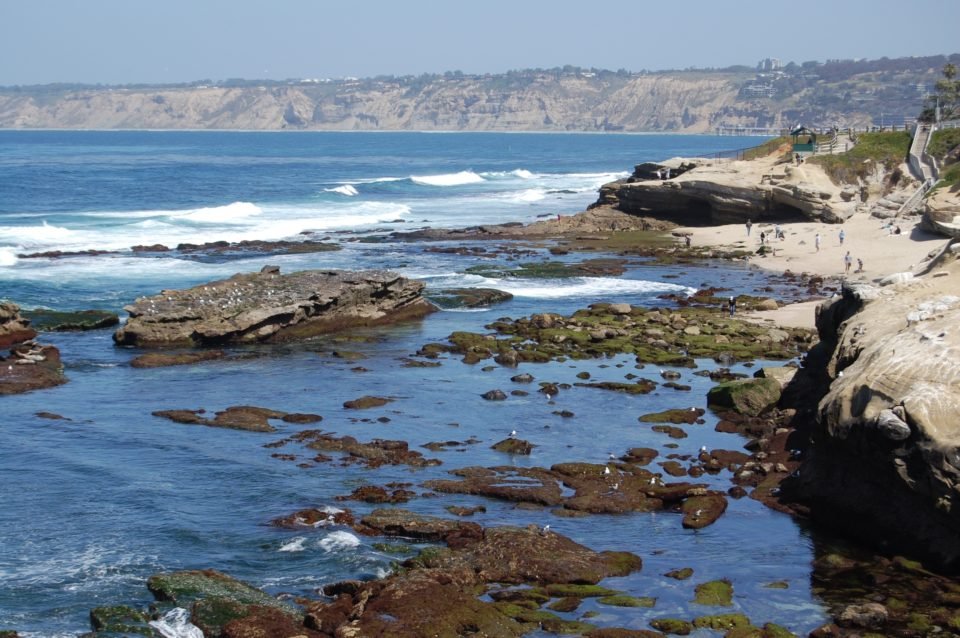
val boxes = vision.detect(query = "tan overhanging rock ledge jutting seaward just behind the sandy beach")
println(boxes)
[594,158,856,226]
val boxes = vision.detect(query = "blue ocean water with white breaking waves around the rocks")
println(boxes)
[0,131,825,636]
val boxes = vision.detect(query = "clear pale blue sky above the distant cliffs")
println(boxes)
[0,0,960,85]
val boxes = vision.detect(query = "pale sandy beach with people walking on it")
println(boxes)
[674,214,949,328]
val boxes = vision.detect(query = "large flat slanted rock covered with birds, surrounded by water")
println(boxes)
[114,268,434,347]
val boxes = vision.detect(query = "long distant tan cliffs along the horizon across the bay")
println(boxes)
[0,56,958,133]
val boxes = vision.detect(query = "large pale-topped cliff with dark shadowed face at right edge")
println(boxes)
[791,242,960,570]
